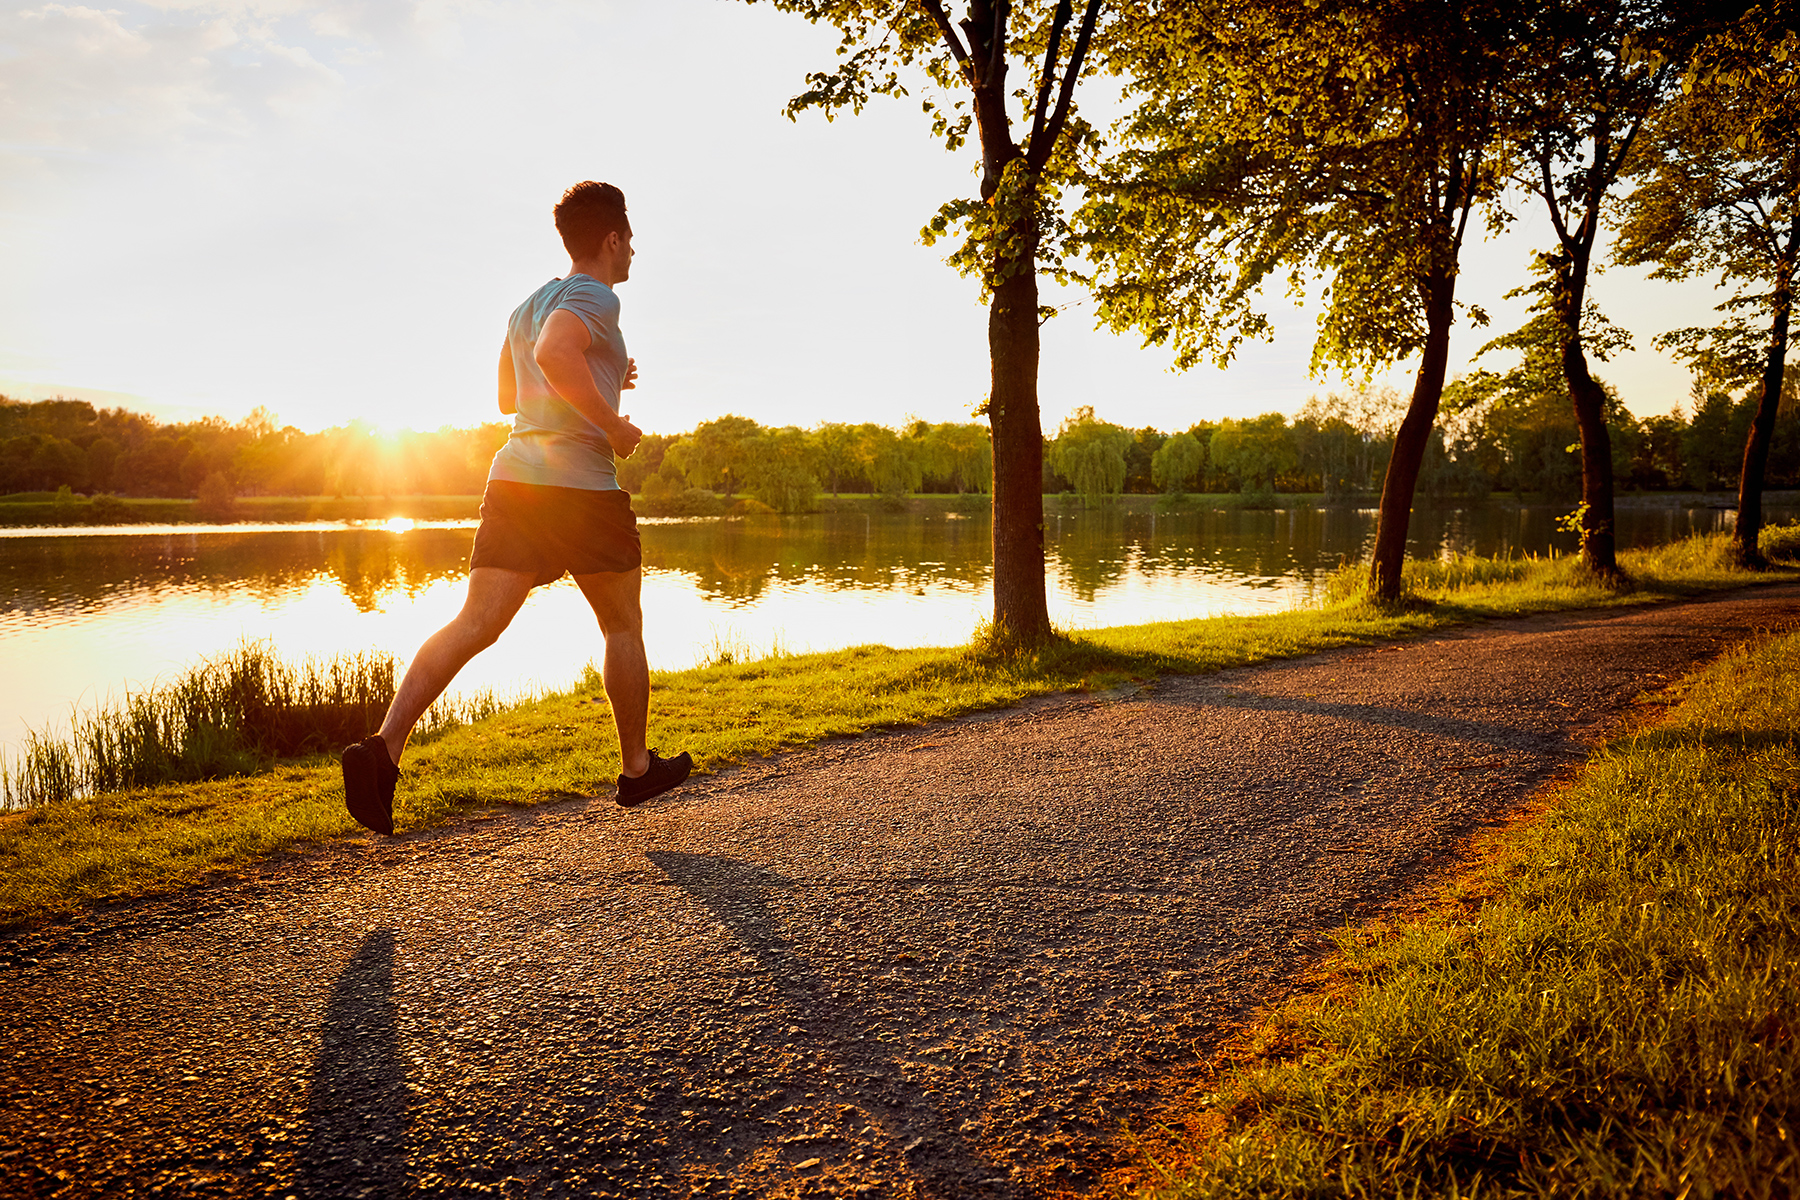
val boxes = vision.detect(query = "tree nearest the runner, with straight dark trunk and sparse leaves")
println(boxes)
[751,0,1100,642]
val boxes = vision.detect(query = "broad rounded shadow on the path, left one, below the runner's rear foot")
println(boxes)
[299,928,412,1198]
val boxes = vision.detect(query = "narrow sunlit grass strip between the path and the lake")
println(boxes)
[0,527,1800,919]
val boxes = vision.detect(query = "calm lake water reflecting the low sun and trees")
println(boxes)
[0,504,1771,752]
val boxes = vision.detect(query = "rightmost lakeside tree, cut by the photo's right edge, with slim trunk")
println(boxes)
[1615,25,1800,565]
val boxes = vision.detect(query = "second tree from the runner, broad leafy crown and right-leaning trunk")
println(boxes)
[1082,0,1519,599]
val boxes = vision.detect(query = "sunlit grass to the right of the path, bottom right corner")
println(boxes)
[1127,635,1800,1200]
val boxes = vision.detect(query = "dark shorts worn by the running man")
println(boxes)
[468,479,644,587]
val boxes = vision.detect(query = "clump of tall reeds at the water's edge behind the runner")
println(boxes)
[0,642,396,808]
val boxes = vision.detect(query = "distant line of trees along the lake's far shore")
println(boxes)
[0,372,1800,513]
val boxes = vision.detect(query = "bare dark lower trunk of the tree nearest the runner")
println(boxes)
[988,253,1049,642]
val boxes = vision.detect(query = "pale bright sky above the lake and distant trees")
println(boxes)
[0,0,1721,434]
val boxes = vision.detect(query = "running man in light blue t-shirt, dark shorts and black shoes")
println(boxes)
[344,182,693,833]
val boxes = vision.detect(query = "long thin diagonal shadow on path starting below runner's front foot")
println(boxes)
[644,851,1019,1196]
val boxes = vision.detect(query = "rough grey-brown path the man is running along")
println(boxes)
[0,587,1800,1200]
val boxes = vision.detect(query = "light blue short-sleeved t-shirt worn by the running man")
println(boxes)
[488,275,628,491]
